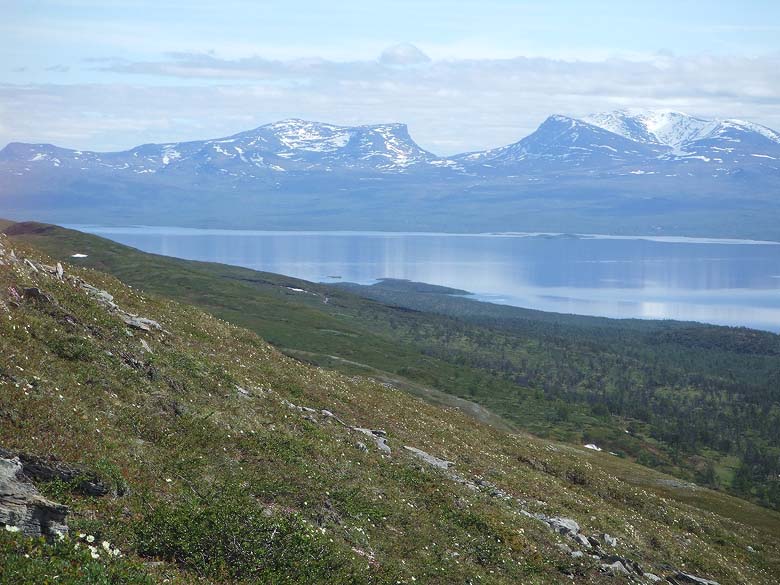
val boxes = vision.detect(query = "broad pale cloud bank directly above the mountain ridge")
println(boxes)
[0,51,780,154]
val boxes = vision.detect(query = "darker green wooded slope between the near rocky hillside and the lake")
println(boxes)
[6,223,780,507]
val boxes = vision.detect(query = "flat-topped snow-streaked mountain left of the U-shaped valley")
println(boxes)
[0,119,442,178]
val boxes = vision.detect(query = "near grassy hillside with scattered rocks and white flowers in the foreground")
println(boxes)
[0,227,780,584]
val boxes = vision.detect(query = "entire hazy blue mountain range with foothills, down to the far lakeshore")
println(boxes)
[0,110,780,239]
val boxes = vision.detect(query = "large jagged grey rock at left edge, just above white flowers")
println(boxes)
[0,457,68,538]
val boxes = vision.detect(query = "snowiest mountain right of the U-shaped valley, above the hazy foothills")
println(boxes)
[452,110,780,178]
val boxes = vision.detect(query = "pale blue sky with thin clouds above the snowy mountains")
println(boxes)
[0,0,780,155]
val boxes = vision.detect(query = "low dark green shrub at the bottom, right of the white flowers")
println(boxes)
[135,486,366,584]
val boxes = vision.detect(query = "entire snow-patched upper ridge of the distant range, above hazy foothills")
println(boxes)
[6,110,780,173]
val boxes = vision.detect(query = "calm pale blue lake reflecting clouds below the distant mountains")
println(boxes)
[72,226,780,332]
